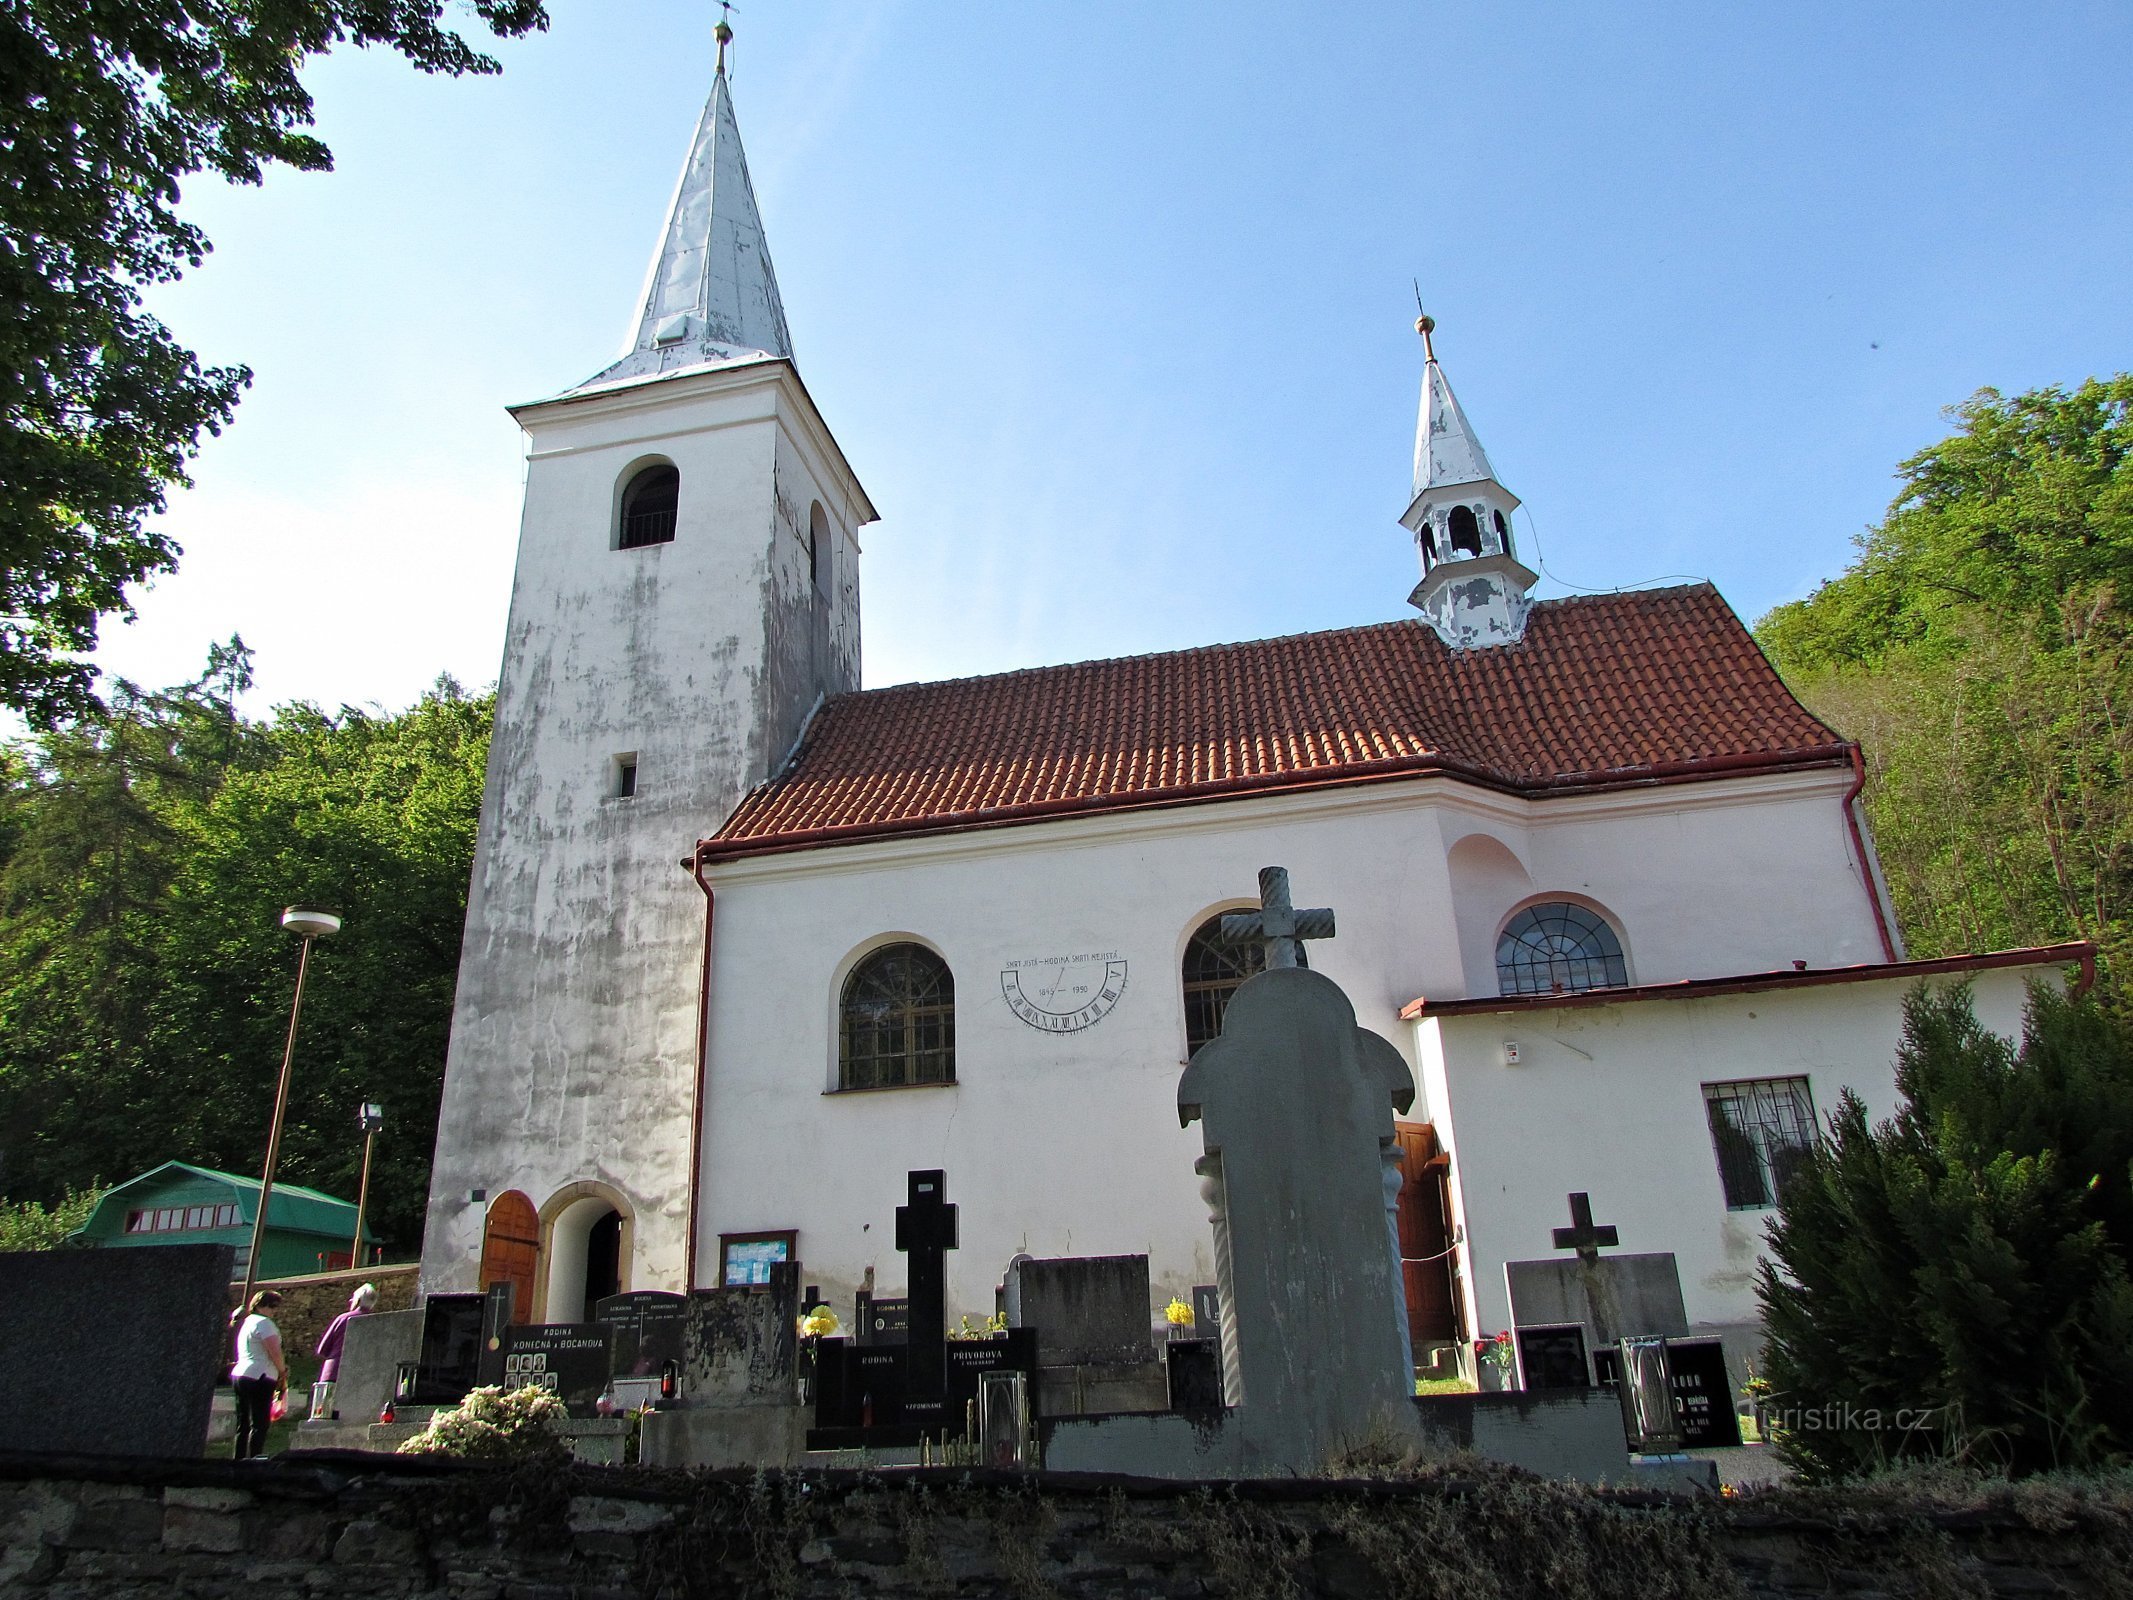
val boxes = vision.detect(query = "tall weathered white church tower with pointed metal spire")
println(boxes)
[422,23,875,1323]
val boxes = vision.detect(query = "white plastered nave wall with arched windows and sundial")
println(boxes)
[697,770,1879,1314]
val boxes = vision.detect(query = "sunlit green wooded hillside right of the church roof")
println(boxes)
[1755,373,2133,1009]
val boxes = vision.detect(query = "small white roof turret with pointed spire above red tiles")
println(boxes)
[1399,316,1534,651]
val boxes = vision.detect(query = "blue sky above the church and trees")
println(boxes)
[98,0,2133,710]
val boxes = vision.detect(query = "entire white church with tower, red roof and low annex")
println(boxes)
[422,40,2084,1390]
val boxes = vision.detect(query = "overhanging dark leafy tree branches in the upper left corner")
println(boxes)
[0,0,548,727]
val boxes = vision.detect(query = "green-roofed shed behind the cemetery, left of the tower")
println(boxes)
[75,1161,378,1278]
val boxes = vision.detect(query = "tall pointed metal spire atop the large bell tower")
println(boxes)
[580,19,793,388]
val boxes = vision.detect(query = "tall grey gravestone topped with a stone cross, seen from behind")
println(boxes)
[1177,866,1416,1470]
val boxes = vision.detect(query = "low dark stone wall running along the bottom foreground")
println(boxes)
[0,1455,2133,1600]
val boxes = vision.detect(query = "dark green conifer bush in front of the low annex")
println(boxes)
[1758,988,2133,1481]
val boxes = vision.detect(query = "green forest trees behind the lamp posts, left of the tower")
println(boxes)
[0,640,491,1244]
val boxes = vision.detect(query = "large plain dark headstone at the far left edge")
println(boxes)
[0,1244,235,1455]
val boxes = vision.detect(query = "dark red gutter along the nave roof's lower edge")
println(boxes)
[695,745,1856,868]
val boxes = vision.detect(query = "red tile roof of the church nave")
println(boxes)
[702,585,1849,860]
